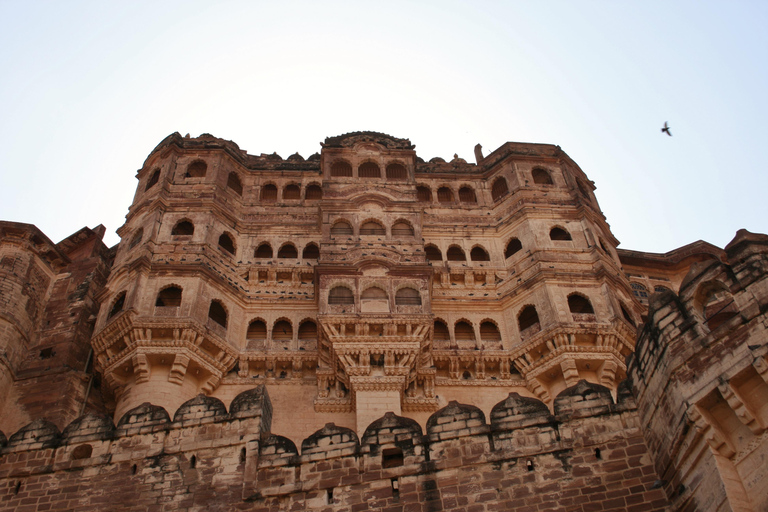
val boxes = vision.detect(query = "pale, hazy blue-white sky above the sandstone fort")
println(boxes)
[0,0,768,252]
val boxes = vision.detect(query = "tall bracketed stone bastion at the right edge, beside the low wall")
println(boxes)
[629,230,768,511]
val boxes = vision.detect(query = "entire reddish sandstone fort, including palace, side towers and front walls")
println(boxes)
[0,132,768,512]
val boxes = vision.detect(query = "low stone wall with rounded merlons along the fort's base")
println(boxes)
[0,382,667,512]
